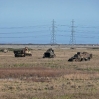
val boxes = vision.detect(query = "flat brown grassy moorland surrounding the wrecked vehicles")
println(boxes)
[0,44,99,99]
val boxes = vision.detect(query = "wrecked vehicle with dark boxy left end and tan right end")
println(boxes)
[14,47,32,57]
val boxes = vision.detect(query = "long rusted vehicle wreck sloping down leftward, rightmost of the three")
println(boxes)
[68,52,92,62]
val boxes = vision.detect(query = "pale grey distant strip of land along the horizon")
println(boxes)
[0,44,99,49]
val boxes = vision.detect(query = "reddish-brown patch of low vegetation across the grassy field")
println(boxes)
[0,67,66,82]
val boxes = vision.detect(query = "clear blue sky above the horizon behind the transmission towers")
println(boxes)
[0,0,99,44]
